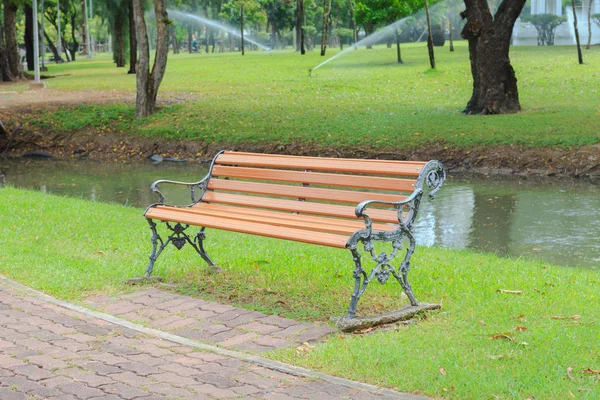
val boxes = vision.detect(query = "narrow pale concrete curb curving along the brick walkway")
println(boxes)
[0,275,429,400]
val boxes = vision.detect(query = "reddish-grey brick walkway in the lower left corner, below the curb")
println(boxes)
[0,280,423,400]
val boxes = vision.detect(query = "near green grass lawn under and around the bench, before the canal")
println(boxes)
[0,187,600,399]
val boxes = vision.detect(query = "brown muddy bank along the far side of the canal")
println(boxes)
[0,126,600,178]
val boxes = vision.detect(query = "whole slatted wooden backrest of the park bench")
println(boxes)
[202,152,426,223]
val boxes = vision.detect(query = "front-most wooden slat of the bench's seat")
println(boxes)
[145,207,349,248]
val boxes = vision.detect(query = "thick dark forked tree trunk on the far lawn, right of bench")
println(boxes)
[461,0,525,114]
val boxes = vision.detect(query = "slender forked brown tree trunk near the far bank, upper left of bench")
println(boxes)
[133,0,170,118]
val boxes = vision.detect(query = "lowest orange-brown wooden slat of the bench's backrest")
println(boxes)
[202,192,398,223]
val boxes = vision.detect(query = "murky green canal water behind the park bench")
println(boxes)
[0,159,600,269]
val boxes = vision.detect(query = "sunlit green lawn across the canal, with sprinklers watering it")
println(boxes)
[13,42,600,150]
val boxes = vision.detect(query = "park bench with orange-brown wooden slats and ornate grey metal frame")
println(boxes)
[144,151,446,318]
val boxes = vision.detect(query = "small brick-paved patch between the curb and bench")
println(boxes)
[86,288,334,352]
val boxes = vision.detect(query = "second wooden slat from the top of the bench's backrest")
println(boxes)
[212,165,416,193]
